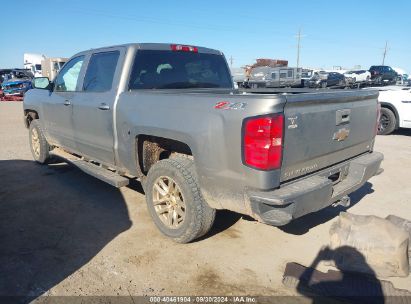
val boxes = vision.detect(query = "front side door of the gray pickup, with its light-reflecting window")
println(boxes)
[44,56,84,151]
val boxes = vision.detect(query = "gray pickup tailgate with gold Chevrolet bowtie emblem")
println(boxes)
[281,90,378,182]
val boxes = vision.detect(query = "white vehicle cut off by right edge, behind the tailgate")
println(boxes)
[378,86,411,135]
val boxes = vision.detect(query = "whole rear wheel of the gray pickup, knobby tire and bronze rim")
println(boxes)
[146,157,215,243]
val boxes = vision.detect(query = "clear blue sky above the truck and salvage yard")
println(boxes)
[0,0,411,72]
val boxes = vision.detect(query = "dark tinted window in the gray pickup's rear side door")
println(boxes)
[83,51,120,92]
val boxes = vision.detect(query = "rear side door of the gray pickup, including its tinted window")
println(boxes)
[73,48,124,164]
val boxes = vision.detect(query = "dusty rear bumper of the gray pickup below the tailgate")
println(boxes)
[246,152,384,226]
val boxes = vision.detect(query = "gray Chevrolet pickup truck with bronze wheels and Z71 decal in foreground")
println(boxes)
[24,44,383,243]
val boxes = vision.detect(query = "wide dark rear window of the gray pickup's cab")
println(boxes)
[130,50,232,90]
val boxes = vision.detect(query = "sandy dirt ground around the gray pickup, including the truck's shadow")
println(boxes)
[0,102,411,298]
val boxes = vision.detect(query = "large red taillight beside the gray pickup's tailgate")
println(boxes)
[243,114,284,170]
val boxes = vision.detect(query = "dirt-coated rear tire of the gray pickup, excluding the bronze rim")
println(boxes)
[145,157,215,243]
